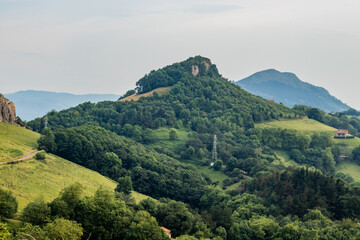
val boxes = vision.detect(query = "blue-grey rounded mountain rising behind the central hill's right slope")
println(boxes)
[235,69,350,112]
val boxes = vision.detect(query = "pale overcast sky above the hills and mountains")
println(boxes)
[0,0,360,109]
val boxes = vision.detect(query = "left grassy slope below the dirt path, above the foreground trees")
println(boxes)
[0,155,116,210]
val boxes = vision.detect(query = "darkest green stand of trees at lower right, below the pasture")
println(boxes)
[248,168,360,219]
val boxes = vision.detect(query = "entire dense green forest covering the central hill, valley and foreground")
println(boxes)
[0,56,360,240]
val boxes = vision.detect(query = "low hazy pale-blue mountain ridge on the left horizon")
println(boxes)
[4,90,119,121]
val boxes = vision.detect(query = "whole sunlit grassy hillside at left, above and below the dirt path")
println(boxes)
[0,123,147,211]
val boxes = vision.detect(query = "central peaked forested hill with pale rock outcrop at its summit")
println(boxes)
[29,56,293,133]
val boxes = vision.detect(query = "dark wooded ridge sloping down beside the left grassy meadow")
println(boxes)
[38,126,206,205]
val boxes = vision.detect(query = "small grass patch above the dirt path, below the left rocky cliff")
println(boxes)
[0,122,40,162]
